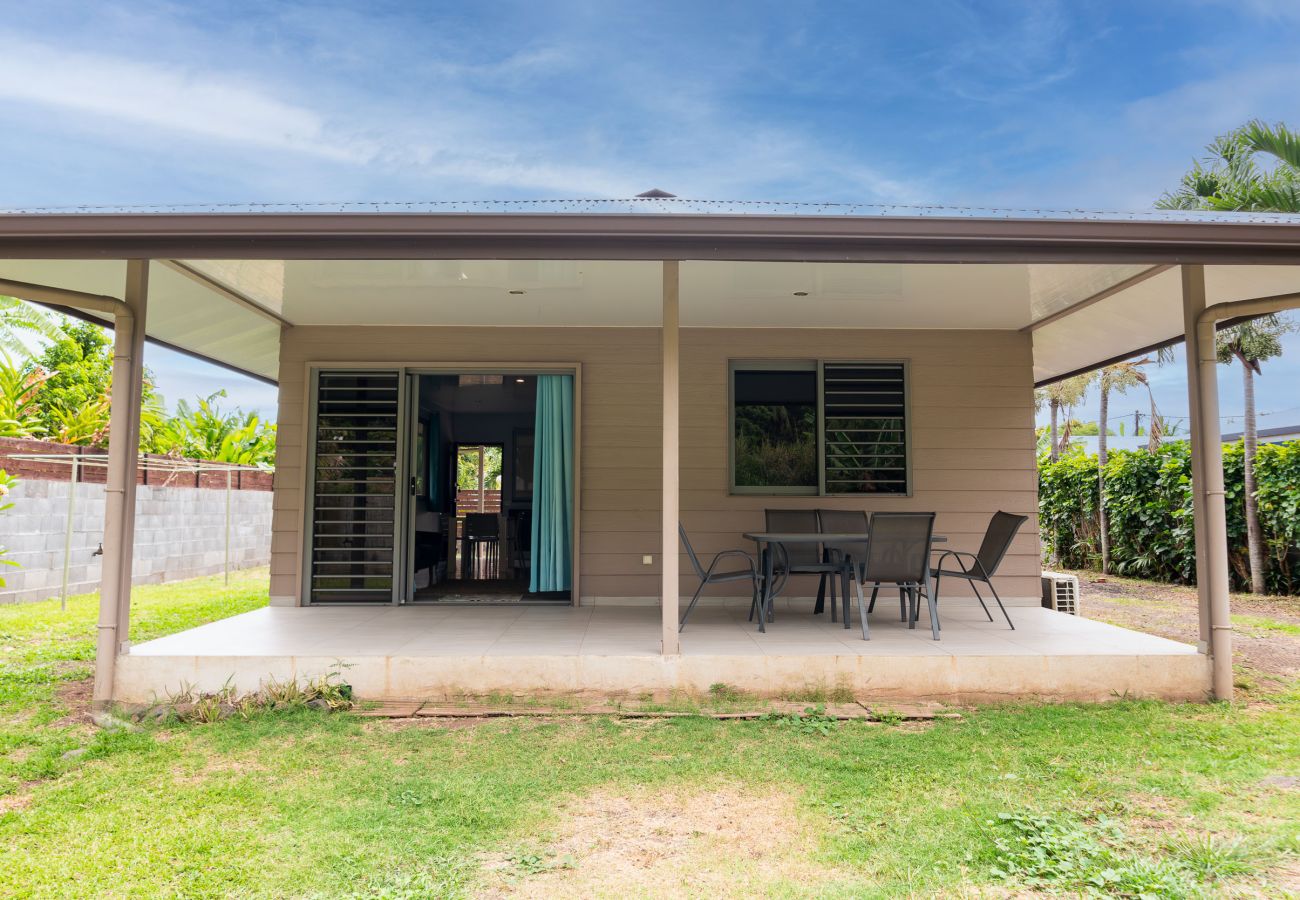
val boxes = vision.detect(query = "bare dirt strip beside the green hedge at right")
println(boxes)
[1075,572,1300,685]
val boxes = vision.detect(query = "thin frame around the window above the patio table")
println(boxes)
[727,358,914,498]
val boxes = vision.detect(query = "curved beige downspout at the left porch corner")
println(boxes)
[0,278,135,705]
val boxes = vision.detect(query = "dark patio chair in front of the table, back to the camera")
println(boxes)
[858,512,939,641]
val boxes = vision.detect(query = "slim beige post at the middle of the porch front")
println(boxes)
[660,260,681,655]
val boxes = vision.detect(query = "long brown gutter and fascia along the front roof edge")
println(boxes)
[0,213,1300,264]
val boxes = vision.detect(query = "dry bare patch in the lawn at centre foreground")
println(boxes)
[478,786,850,897]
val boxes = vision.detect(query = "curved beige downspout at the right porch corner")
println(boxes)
[1193,291,1300,700]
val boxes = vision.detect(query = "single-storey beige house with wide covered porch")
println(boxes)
[0,198,1300,702]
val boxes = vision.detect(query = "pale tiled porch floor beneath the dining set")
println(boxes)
[131,598,1195,657]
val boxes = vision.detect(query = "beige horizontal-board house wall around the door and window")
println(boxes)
[272,326,1039,602]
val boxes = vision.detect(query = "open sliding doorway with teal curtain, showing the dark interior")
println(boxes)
[404,372,573,603]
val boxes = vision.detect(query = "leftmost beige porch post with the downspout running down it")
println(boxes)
[94,259,148,708]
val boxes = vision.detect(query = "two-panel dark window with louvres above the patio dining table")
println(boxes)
[731,360,911,494]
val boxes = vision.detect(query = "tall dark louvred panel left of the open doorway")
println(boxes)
[309,372,399,603]
